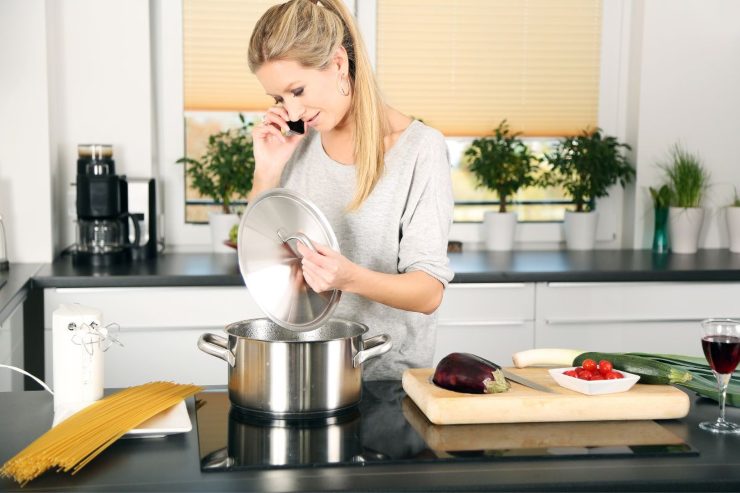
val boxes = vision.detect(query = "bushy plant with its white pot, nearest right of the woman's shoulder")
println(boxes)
[465,120,537,251]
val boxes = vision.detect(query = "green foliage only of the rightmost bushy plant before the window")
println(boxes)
[545,128,635,212]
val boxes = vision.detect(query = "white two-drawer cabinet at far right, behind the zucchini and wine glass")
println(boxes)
[535,282,740,356]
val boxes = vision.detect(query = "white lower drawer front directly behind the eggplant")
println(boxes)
[434,321,534,366]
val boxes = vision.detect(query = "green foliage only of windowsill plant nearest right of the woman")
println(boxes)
[465,120,538,212]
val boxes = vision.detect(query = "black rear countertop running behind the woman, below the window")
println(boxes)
[27,249,740,288]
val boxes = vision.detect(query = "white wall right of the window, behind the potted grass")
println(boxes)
[630,0,740,248]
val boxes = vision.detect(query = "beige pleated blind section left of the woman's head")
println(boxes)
[183,0,278,111]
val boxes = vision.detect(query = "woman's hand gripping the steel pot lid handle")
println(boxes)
[298,242,358,293]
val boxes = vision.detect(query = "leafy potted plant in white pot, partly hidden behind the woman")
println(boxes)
[177,113,254,252]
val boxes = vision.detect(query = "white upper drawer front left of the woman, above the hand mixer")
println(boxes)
[44,287,264,328]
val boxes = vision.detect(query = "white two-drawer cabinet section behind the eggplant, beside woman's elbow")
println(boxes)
[434,283,535,365]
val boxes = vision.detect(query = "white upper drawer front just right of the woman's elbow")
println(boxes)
[439,283,535,324]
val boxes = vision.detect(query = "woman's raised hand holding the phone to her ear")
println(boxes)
[252,106,306,188]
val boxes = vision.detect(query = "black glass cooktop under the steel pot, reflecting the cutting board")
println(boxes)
[196,381,698,471]
